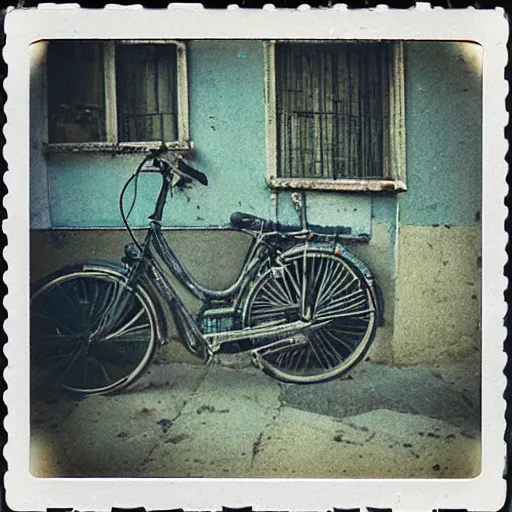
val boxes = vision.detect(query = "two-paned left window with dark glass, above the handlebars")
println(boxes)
[47,41,189,150]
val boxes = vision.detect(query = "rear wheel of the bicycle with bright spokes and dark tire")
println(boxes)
[244,249,376,384]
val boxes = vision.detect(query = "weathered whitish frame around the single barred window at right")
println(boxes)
[264,40,407,192]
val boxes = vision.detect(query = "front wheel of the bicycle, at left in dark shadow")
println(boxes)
[30,269,158,394]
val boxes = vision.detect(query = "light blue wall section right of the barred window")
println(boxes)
[400,42,482,225]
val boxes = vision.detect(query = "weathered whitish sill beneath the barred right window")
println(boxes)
[267,178,407,193]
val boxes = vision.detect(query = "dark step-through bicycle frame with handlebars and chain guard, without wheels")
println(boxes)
[121,154,382,357]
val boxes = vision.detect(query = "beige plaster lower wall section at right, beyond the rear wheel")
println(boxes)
[393,226,481,363]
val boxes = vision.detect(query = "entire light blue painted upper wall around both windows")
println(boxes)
[43,40,481,234]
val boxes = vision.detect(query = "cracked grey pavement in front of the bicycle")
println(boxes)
[31,362,481,478]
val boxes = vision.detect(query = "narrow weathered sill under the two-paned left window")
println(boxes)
[43,141,194,154]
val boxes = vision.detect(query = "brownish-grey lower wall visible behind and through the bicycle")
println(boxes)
[30,217,394,362]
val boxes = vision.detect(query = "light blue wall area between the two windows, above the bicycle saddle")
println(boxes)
[170,41,270,225]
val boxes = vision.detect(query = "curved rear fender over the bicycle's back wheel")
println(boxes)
[281,242,384,327]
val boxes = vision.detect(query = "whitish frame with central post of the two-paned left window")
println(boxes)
[43,39,193,153]
